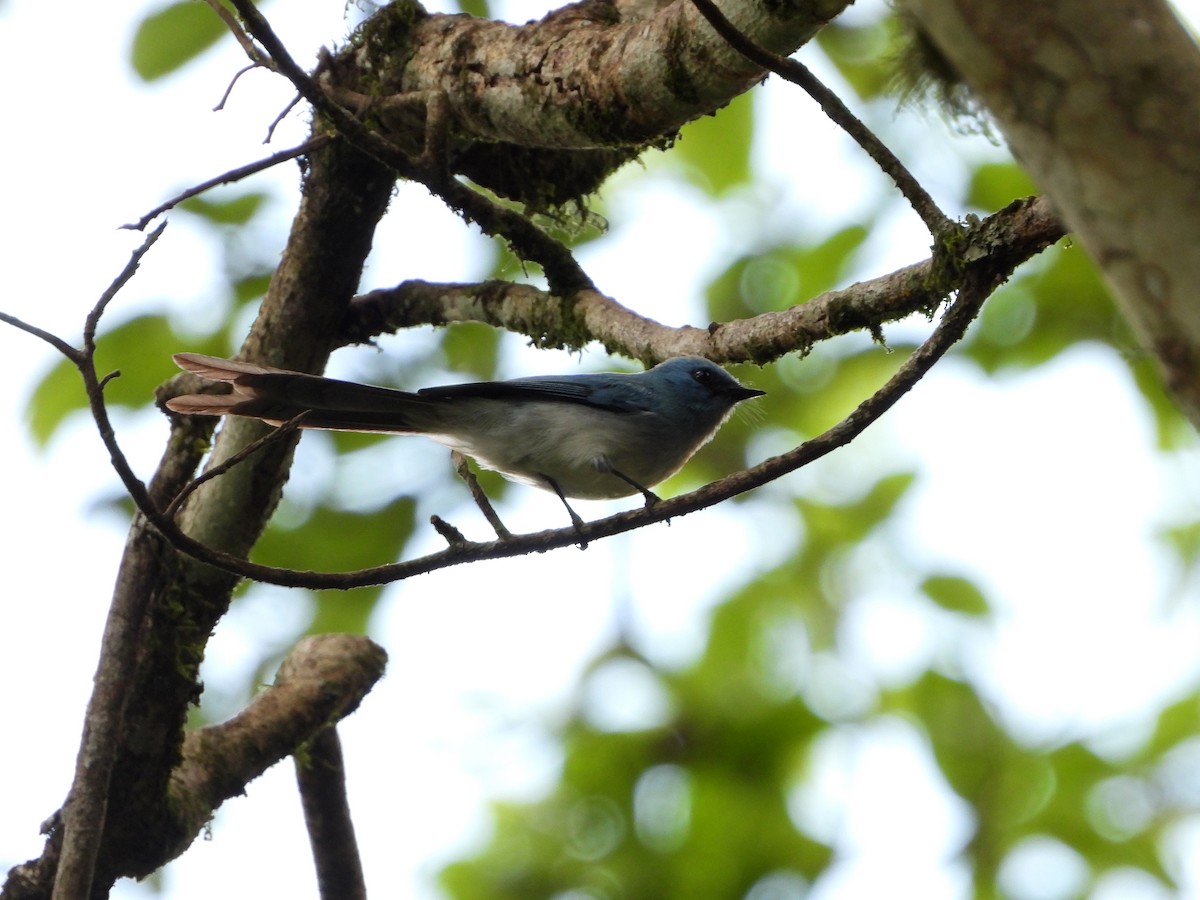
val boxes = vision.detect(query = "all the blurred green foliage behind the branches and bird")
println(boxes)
[21,0,1200,900]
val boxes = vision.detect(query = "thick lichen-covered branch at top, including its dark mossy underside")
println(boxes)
[323,0,848,210]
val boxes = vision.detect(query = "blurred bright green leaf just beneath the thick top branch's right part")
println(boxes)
[671,92,754,197]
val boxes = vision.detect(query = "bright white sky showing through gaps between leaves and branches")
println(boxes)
[0,0,1200,900]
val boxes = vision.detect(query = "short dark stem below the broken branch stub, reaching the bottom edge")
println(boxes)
[294,726,367,900]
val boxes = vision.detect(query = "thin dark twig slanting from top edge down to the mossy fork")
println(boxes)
[691,0,959,238]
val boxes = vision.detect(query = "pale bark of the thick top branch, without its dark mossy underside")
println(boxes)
[336,0,848,149]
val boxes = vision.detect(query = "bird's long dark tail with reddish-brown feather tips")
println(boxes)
[167,353,432,432]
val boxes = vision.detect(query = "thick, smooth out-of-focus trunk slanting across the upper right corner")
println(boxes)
[905,0,1200,426]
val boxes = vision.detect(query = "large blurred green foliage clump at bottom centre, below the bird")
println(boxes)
[442,475,911,900]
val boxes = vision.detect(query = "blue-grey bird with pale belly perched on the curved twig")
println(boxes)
[166,353,764,528]
